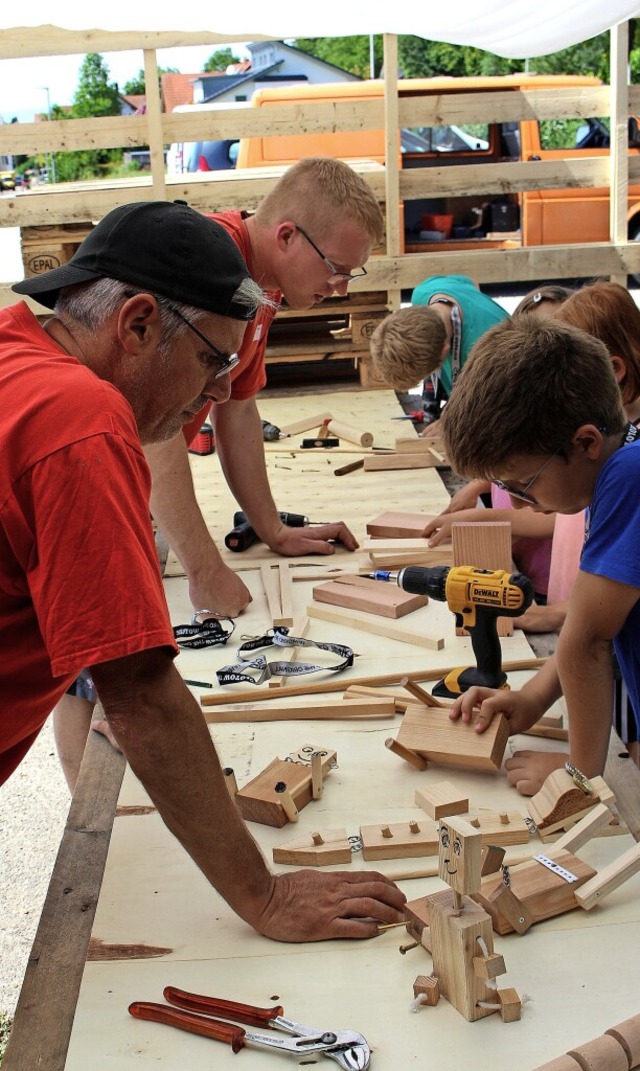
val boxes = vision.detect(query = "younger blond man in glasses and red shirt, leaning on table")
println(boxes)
[147,157,384,617]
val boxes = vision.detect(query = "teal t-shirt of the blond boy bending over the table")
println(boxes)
[411,275,508,396]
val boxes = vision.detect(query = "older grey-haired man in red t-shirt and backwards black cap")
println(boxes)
[5,201,403,940]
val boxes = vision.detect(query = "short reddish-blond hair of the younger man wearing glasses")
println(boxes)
[255,156,384,245]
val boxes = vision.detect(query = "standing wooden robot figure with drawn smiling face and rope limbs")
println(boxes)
[406,817,522,1023]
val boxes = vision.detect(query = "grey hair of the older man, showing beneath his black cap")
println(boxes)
[55,278,275,352]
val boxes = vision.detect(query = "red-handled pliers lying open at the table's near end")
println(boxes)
[128,985,370,1071]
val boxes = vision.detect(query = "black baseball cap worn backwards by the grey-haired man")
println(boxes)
[12,200,256,320]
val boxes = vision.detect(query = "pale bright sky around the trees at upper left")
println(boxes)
[0,44,250,123]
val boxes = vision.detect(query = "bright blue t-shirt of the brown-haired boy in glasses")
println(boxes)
[580,441,640,711]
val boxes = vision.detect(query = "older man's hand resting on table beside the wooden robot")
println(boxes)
[255,870,407,941]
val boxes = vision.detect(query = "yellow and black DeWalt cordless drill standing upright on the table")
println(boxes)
[369,565,533,699]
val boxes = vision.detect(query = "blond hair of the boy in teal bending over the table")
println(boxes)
[369,305,446,391]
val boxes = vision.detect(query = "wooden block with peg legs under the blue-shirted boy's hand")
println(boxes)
[396,707,508,770]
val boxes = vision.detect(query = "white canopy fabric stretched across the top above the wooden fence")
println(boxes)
[0,0,640,59]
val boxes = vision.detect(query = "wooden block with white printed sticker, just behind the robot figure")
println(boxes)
[473,851,596,934]
